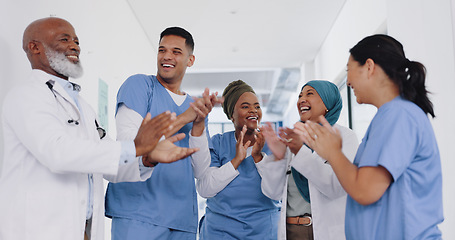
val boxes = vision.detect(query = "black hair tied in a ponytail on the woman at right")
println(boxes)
[349,34,435,118]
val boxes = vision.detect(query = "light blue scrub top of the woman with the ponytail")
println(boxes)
[346,97,443,240]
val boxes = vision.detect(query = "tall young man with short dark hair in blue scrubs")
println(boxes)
[106,27,211,240]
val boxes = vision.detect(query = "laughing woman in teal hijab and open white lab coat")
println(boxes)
[258,80,358,240]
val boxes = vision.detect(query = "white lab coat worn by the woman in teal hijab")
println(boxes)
[257,124,358,240]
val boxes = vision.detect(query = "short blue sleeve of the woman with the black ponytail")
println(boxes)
[359,107,418,180]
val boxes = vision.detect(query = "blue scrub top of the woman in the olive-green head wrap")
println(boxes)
[200,131,280,240]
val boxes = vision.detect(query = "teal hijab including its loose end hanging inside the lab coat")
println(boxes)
[291,80,343,202]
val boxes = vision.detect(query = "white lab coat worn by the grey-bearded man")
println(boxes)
[0,70,150,240]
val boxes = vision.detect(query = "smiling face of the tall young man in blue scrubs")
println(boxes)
[157,35,194,83]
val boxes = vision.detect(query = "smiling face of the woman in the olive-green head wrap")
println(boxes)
[231,92,262,131]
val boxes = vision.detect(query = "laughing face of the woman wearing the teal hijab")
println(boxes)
[297,85,327,122]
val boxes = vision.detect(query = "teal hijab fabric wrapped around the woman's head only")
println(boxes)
[300,80,343,125]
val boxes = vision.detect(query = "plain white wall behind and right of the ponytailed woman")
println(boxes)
[307,0,455,239]
